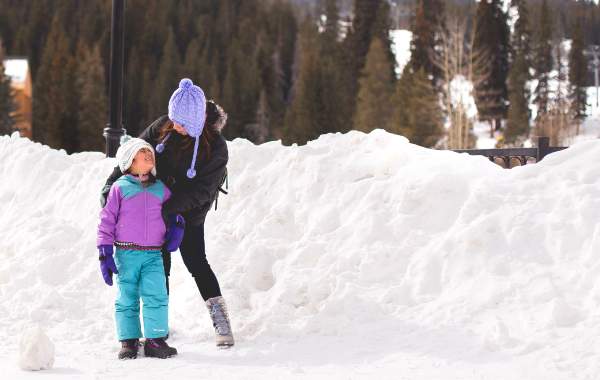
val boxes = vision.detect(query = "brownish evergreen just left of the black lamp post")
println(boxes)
[77,45,108,151]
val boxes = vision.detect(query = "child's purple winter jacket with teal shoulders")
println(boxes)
[97,174,171,247]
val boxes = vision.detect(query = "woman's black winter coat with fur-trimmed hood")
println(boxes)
[100,115,229,225]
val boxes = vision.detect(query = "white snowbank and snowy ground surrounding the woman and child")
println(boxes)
[0,130,600,380]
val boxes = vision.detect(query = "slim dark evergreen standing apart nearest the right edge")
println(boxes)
[569,23,587,132]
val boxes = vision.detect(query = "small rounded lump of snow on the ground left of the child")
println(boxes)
[19,326,54,371]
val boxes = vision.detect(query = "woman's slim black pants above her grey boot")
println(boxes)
[162,224,221,301]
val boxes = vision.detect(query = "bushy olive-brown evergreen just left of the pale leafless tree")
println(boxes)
[388,67,444,147]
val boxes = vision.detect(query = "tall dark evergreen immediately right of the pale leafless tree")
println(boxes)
[474,0,510,130]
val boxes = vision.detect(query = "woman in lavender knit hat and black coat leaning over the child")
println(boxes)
[101,78,234,348]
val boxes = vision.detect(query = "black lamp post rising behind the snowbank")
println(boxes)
[104,0,126,157]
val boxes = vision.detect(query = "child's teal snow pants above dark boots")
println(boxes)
[115,248,169,340]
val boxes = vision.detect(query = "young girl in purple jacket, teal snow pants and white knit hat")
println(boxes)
[97,138,182,359]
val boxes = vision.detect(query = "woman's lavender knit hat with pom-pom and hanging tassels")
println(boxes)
[156,78,206,178]
